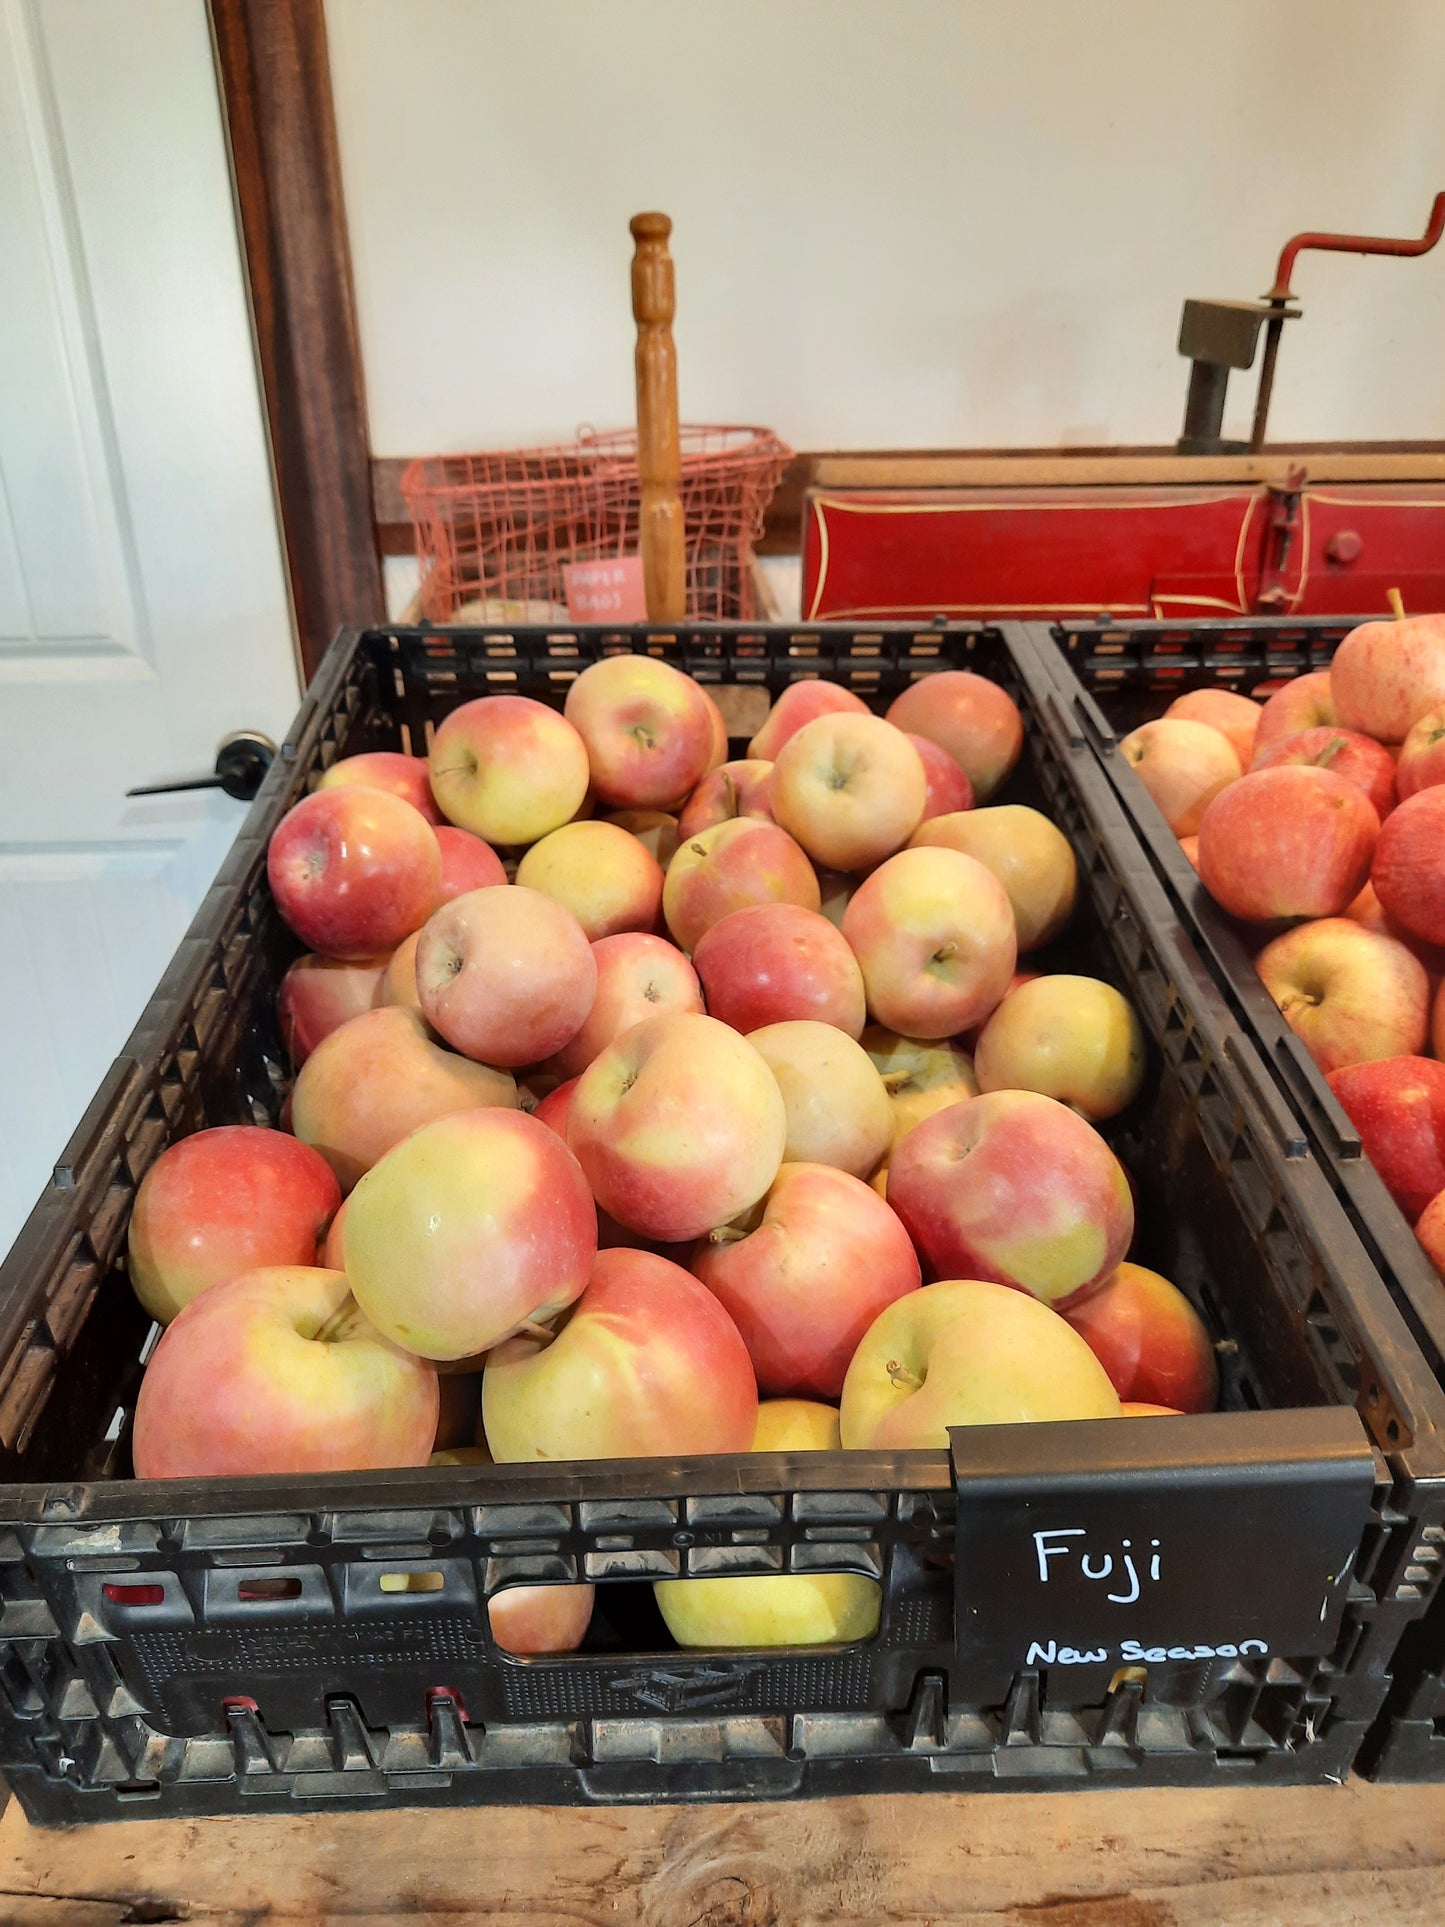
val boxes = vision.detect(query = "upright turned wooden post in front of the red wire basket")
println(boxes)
[630,214,688,622]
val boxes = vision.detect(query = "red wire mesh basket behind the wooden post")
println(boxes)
[401,424,792,622]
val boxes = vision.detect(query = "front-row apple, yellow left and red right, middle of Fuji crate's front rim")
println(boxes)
[482,1251,757,1465]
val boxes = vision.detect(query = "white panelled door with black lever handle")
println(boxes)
[0,0,299,1253]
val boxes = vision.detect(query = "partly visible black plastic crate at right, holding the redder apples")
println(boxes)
[1031,617,1445,1781]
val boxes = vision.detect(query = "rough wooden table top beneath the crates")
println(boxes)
[0,1781,1445,1927]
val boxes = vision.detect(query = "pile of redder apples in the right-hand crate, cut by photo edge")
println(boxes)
[1119,615,1445,1276]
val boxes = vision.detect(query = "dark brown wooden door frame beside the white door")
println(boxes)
[208,0,385,676]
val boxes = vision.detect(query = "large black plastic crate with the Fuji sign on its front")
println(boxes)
[0,624,1445,1821]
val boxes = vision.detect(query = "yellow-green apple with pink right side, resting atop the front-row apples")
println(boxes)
[341,1110,597,1359]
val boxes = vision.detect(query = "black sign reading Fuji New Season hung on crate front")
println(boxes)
[950,1409,1376,1703]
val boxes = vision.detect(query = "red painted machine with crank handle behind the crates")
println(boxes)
[801,193,1445,620]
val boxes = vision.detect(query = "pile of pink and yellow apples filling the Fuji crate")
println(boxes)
[129,655,1218,1651]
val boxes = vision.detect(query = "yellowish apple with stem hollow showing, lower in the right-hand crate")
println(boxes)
[1254,917,1430,1071]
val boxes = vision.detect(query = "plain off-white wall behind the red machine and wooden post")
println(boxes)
[328,0,1445,455]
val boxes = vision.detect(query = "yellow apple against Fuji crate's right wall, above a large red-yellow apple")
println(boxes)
[973,973,1146,1123]
